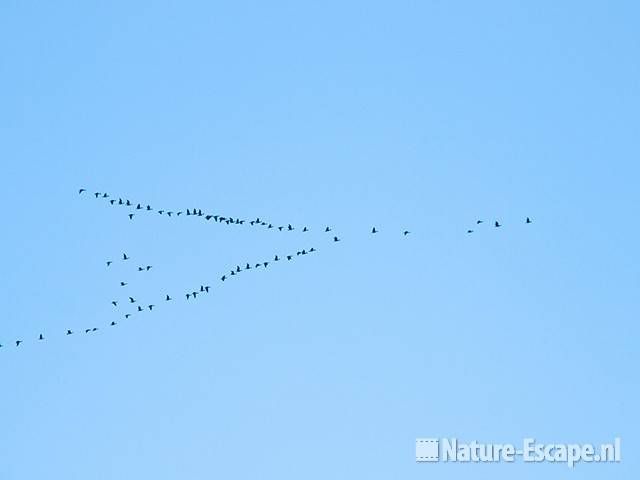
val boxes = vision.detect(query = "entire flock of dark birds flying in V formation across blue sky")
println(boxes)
[0,188,532,348]
